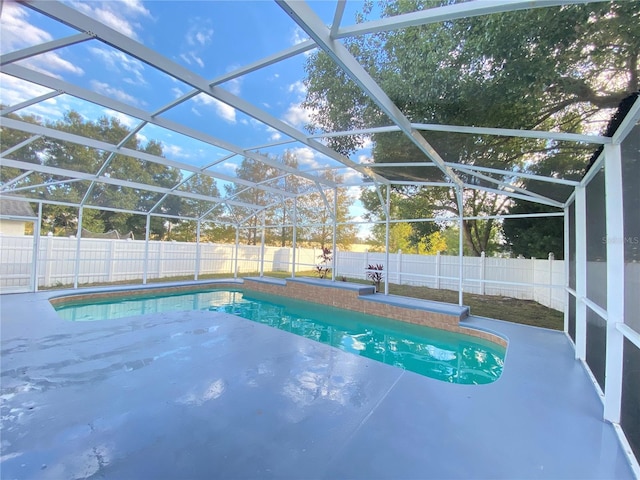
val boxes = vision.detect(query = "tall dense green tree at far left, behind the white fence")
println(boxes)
[1,110,182,238]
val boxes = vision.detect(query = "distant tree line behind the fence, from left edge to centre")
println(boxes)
[0,111,357,247]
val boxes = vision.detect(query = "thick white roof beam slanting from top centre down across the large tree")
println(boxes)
[277,0,463,187]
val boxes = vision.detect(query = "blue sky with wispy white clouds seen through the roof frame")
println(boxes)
[0,0,378,232]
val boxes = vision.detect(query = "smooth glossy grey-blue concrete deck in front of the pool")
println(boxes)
[0,289,633,480]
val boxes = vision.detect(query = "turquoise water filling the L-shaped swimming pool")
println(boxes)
[56,290,505,384]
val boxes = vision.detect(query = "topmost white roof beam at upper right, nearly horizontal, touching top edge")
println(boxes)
[336,0,602,38]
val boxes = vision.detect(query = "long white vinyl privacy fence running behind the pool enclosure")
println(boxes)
[0,235,565,311]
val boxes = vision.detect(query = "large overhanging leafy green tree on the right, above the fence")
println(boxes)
[305,0,640,255]
